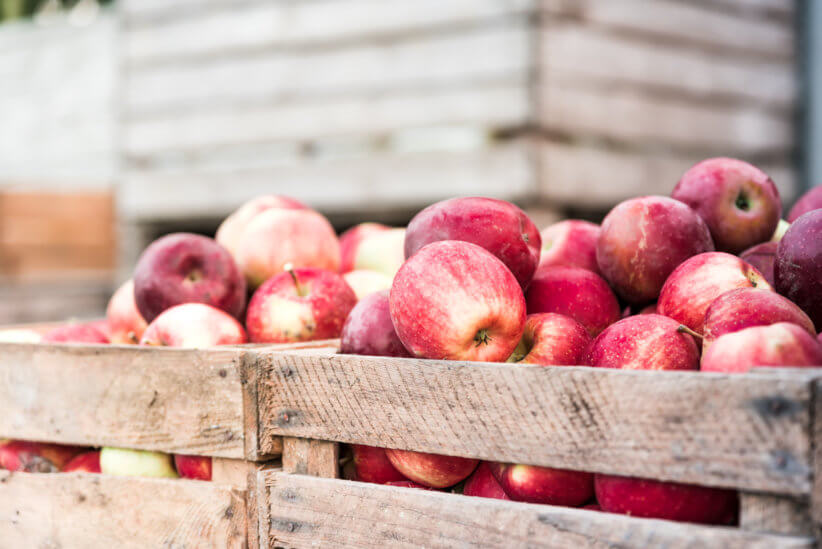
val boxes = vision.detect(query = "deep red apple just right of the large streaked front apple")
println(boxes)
[525,267,621,337]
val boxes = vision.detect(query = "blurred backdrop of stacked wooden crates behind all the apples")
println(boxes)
[0,0,822,322]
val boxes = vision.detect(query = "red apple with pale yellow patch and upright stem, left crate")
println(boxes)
[245,266,357,343]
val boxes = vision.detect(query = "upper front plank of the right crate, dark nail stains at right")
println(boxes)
[258,352,812,495]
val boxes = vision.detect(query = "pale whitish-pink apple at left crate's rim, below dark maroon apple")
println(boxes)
[140,303,248,349]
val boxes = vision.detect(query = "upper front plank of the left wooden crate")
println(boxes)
[0,344,244,458]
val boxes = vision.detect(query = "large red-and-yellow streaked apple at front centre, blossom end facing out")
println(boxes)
[389,240,525,362]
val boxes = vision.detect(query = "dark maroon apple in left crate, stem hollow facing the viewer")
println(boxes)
[134,233,246,323]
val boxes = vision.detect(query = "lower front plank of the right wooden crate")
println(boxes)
[258,472,813,549]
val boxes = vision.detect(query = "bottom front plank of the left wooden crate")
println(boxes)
[0,471,246,548]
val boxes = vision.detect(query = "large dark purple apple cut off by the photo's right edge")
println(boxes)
[774,209,822,332]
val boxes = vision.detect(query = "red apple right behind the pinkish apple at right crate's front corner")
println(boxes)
[702,288,816,346]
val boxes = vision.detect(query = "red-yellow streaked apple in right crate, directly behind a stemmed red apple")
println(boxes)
[657,252,773,334]
